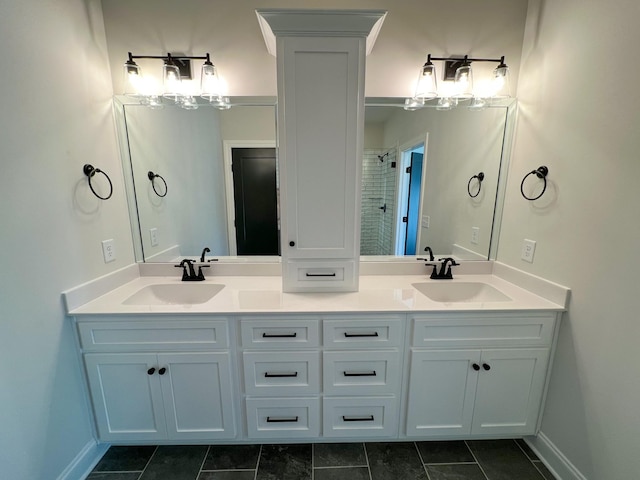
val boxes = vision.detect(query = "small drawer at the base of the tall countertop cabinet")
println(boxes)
[283,260,357,292]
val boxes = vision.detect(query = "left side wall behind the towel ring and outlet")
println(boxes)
[0,0,133,480]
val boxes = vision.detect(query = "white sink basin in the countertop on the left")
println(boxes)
[122,283,224,305]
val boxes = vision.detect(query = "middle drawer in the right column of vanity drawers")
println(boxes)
[323,350,402,395]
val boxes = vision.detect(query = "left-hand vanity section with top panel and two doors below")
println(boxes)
[77,318,236,442]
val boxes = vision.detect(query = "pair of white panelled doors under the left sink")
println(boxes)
[84,352,236,441]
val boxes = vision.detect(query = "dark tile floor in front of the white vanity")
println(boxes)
[87,440,554,480]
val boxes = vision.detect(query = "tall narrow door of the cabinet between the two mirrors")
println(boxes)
[277,37,365,260]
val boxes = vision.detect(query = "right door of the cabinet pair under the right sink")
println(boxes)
[472,348,549,435]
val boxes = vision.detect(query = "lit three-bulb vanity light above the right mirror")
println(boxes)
[405,54,511,110]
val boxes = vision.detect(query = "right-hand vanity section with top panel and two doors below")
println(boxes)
[406,313,556,438]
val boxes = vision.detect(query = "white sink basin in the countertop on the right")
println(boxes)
[411,280,511,302]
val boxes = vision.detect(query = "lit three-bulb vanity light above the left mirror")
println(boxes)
[124,52,230,110]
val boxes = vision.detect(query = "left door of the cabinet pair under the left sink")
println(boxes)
[84,353,166,441]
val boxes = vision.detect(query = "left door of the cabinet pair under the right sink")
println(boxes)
[407,350,480,437]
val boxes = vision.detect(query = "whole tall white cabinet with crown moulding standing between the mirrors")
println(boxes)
[257,10,386,292]
